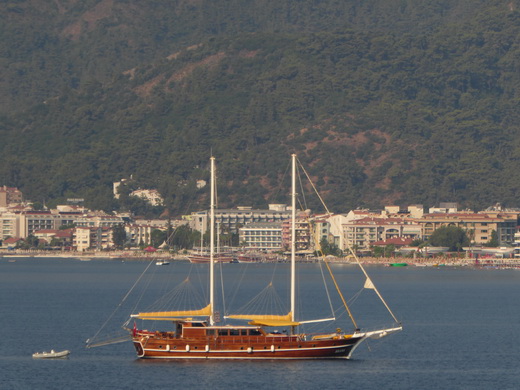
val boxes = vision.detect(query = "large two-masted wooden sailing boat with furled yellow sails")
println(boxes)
[127,155,402,359]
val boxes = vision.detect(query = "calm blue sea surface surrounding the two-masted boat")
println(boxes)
[0,258,520,389]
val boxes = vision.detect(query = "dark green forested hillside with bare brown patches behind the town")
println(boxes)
[0,0,520,215]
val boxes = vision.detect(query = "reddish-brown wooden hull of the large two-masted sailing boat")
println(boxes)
[133,335,364,360]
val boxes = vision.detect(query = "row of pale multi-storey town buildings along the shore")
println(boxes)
[0,186,520,268]
